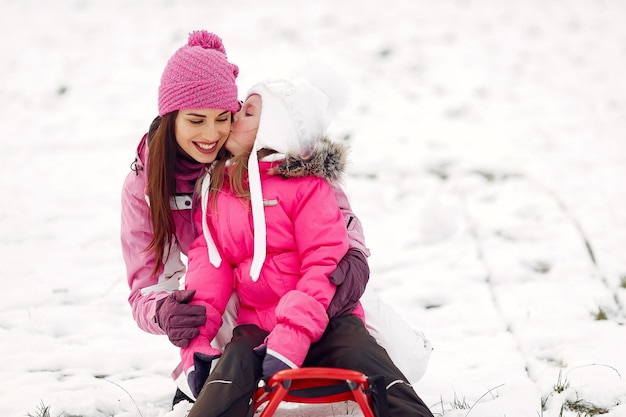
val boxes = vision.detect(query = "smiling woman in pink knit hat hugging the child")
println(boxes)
[121,31,369,403]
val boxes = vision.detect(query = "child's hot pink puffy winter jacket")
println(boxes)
[181,162,352,371]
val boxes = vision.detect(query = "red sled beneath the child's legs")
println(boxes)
[254,367,374,417]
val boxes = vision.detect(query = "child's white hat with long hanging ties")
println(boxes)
[202,77,344,282]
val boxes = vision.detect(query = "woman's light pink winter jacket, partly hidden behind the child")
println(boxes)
[120,135,369,334]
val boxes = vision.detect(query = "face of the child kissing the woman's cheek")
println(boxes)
[225,94,261,156]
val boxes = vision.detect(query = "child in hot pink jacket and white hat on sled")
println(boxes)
[181,75,432,417]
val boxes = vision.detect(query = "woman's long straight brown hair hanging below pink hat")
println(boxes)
[146,111,178,276]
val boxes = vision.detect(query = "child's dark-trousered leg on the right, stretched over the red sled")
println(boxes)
[303,316,433,417]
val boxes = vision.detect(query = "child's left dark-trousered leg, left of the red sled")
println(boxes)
[188,324,267,417]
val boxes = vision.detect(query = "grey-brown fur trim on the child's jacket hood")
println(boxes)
[270,137,348,184]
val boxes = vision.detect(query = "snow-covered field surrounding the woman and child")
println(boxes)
[0,0,626,417]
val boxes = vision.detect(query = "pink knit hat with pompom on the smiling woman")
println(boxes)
[159,30,240,116]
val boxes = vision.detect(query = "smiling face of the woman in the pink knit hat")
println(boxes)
[174,109,231,164]
